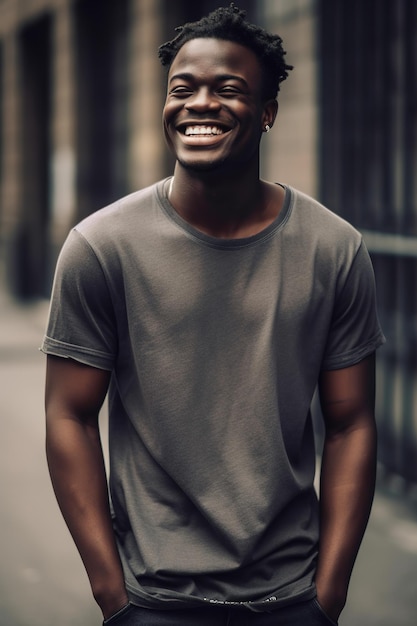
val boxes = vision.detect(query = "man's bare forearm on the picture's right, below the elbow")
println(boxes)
[316,420,376,618]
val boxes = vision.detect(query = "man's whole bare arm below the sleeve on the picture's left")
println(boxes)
[45,356,128,618]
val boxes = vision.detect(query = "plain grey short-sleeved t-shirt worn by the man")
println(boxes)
[43,180,383,610]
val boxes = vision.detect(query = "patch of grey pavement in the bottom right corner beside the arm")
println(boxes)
[340,470,417,626]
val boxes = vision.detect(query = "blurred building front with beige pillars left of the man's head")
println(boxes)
[0,0,165,298]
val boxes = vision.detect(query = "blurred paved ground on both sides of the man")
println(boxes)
[0,297,417,626]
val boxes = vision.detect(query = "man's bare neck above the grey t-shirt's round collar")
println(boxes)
[169,166,284,239]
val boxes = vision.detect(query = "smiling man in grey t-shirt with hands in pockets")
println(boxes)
[43,5,383,626]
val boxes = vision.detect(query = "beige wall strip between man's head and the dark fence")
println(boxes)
[260,0,318,196]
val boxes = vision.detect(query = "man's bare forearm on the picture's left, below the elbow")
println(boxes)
[46,416,127,617]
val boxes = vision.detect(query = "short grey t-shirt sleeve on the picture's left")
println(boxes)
[41,229,117,370]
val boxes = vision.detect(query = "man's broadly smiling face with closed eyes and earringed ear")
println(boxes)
[163,38,276,171]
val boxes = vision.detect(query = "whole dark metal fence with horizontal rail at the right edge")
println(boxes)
[319,0,417,483]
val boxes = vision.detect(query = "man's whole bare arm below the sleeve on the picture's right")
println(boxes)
[316,354,376,621]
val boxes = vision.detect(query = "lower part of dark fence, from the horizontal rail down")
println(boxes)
[364,239,417,483]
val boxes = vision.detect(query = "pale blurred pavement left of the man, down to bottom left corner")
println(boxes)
[0,292,101,626]
